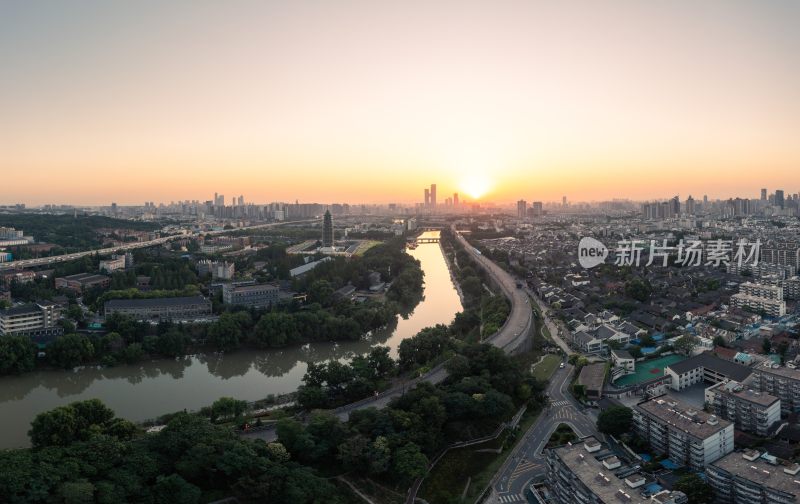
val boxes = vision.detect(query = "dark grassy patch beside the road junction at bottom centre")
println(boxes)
[419,413,538,504]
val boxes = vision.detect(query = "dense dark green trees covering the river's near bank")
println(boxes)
[0,227,532,504]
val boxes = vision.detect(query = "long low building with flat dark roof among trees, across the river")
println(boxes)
[105,296,211,320]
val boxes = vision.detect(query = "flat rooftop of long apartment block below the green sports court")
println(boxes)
[634,395,731,439]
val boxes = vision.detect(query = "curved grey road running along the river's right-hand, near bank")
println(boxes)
[242,229,533,441]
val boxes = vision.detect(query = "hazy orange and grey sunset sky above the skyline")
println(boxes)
[0,0,800,205]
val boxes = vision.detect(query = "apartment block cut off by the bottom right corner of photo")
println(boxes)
[706,450,800,504]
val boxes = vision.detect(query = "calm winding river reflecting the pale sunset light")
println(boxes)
[0,232,462,449]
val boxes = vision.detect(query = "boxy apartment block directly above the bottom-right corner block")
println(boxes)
[705,381,781,436]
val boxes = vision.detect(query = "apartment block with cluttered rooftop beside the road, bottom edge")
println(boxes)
[545,438,688,504]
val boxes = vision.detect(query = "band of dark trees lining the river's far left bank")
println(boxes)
[0,238,424,379]
